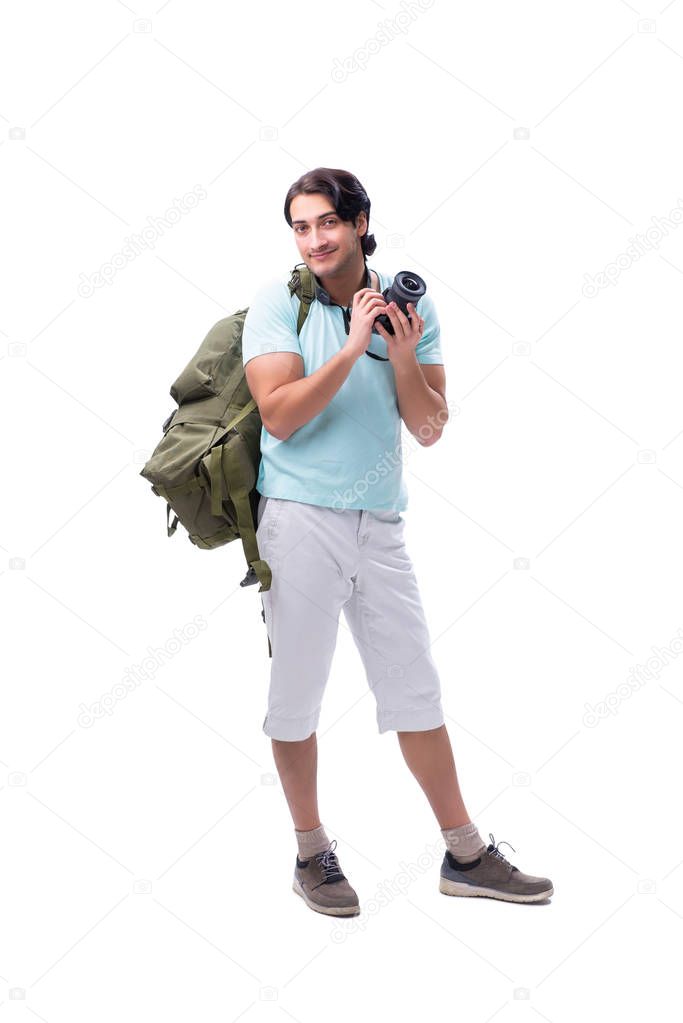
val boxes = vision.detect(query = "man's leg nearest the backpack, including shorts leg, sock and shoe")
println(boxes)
[257,498,360,917]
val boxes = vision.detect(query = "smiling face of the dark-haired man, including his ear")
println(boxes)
[289,192,367,277]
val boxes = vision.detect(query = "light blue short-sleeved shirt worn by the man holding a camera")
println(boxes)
[242,267,444,512]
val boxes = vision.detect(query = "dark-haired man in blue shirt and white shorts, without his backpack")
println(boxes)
[242,168,553,916]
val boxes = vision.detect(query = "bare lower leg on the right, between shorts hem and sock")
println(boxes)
[397,724,470,829]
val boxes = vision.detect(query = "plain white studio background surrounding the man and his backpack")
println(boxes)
[0,0,683,1023]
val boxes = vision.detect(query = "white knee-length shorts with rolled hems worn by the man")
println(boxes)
[257,495,444,741]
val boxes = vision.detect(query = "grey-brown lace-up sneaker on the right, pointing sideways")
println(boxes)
[439,832,554,902]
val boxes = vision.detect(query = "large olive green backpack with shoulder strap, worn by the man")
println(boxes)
[140,263,315,605]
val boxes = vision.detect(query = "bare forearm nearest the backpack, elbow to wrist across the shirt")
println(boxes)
[261,346,357,441]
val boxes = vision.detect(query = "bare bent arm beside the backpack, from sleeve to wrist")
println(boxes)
[244,345,358,441]
